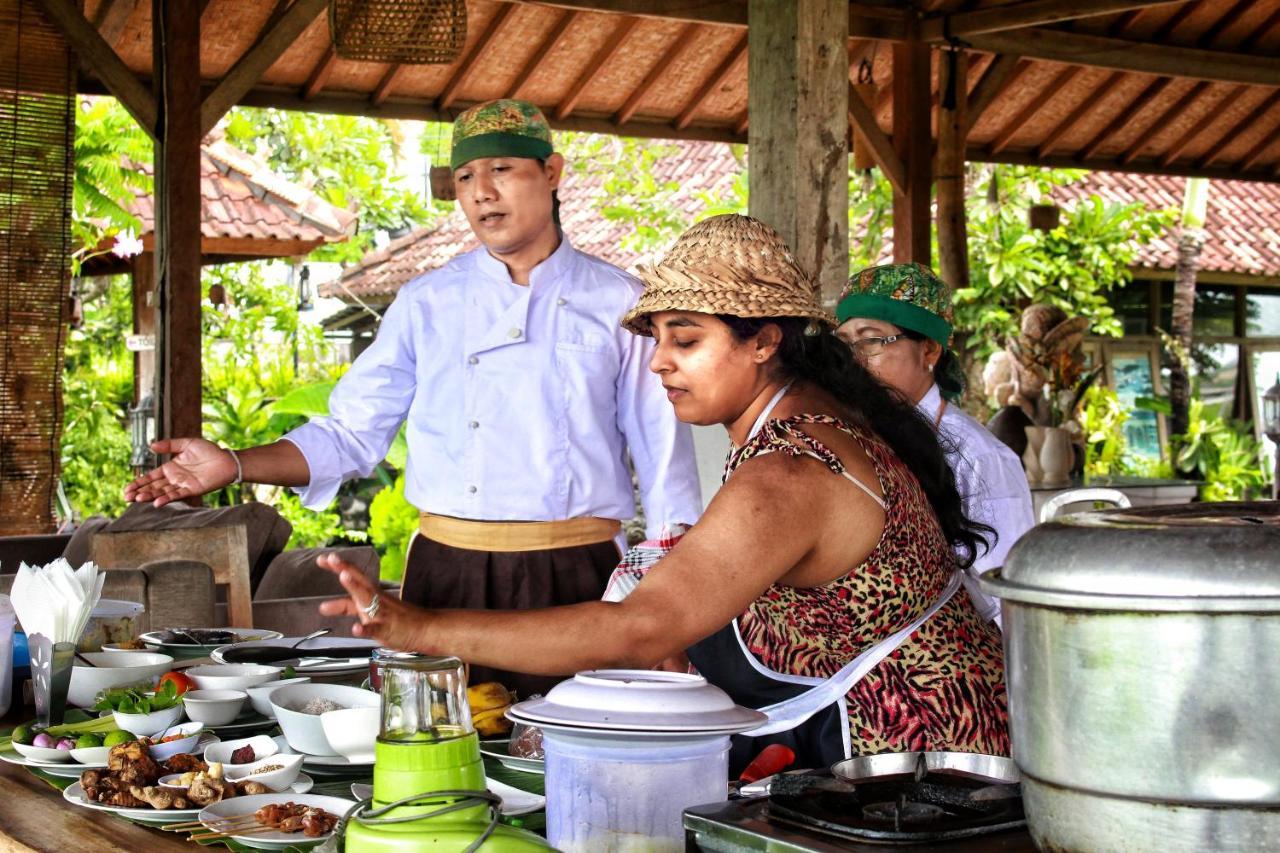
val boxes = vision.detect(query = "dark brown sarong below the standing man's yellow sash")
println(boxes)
[401,534,621,699]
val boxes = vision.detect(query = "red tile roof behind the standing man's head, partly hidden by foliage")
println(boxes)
[319,142,741,305]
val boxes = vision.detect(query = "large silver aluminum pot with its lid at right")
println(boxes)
[982,503,1280,853]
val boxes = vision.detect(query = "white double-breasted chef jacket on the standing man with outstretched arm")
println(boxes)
[284,238,701,537]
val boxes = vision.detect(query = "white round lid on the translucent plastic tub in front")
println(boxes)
[509,670,768,734]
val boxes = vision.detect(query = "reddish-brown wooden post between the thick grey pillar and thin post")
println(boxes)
[892,41,933,265]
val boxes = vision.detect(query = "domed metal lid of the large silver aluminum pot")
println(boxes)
[982,502,1280,612]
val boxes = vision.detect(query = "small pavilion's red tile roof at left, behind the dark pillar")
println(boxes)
[131,138,356,247]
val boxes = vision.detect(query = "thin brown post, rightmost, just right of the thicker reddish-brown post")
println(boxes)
[937,50,969,288]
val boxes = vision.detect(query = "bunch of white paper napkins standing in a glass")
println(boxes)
[9,557,106,643]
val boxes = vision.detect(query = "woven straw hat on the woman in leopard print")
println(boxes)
[622,214,835,336]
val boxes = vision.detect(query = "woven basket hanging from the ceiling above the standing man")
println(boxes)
[329,0,467,65]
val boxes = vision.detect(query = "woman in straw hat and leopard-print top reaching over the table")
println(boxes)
[321,215,1009,766]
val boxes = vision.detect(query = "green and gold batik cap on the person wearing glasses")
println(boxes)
[836,263,955,348]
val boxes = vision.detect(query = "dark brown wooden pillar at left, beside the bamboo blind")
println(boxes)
[151,0,201,438]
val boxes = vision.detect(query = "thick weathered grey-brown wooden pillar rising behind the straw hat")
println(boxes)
[746,0,849,305]
